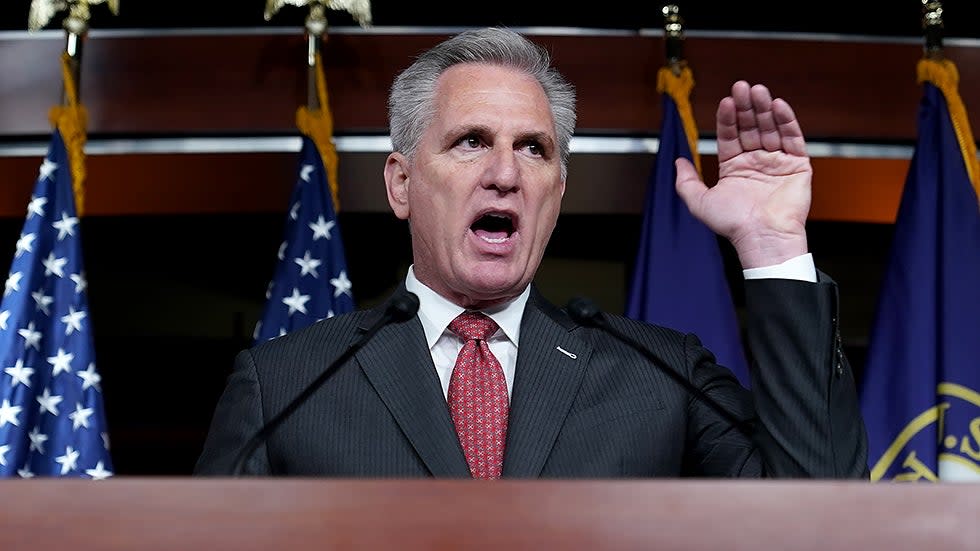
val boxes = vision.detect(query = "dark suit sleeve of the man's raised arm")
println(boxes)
[745,272,869,478]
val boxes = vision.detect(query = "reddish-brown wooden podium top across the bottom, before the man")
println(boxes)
[0,477,980,551]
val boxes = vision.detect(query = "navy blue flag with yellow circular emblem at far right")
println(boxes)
[861,61,980,482]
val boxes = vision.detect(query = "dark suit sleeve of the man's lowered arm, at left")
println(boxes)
[194,350,269,476]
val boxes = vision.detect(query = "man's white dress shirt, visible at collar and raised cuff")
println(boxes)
[405,253,817,397]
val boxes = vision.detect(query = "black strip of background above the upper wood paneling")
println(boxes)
[0,0,980,37]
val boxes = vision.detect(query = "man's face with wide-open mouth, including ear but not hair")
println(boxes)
[385,63,565,307]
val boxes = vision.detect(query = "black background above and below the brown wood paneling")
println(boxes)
[0,0,964,475]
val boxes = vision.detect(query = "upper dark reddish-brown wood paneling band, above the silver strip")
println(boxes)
[0,32,980,141]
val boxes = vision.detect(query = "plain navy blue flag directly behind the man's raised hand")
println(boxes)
[626,71,749,387]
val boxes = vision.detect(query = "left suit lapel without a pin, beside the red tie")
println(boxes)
[356,300,470,477]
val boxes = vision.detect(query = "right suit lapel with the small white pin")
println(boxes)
[503,289,592,477]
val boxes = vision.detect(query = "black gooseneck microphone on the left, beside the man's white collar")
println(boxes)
[231,290,419,477]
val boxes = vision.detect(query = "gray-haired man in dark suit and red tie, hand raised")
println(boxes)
[196,28,867,479]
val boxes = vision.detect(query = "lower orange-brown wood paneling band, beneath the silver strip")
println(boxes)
[0,152,909,223]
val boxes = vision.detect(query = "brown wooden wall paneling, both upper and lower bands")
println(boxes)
[0,31,968,222]
